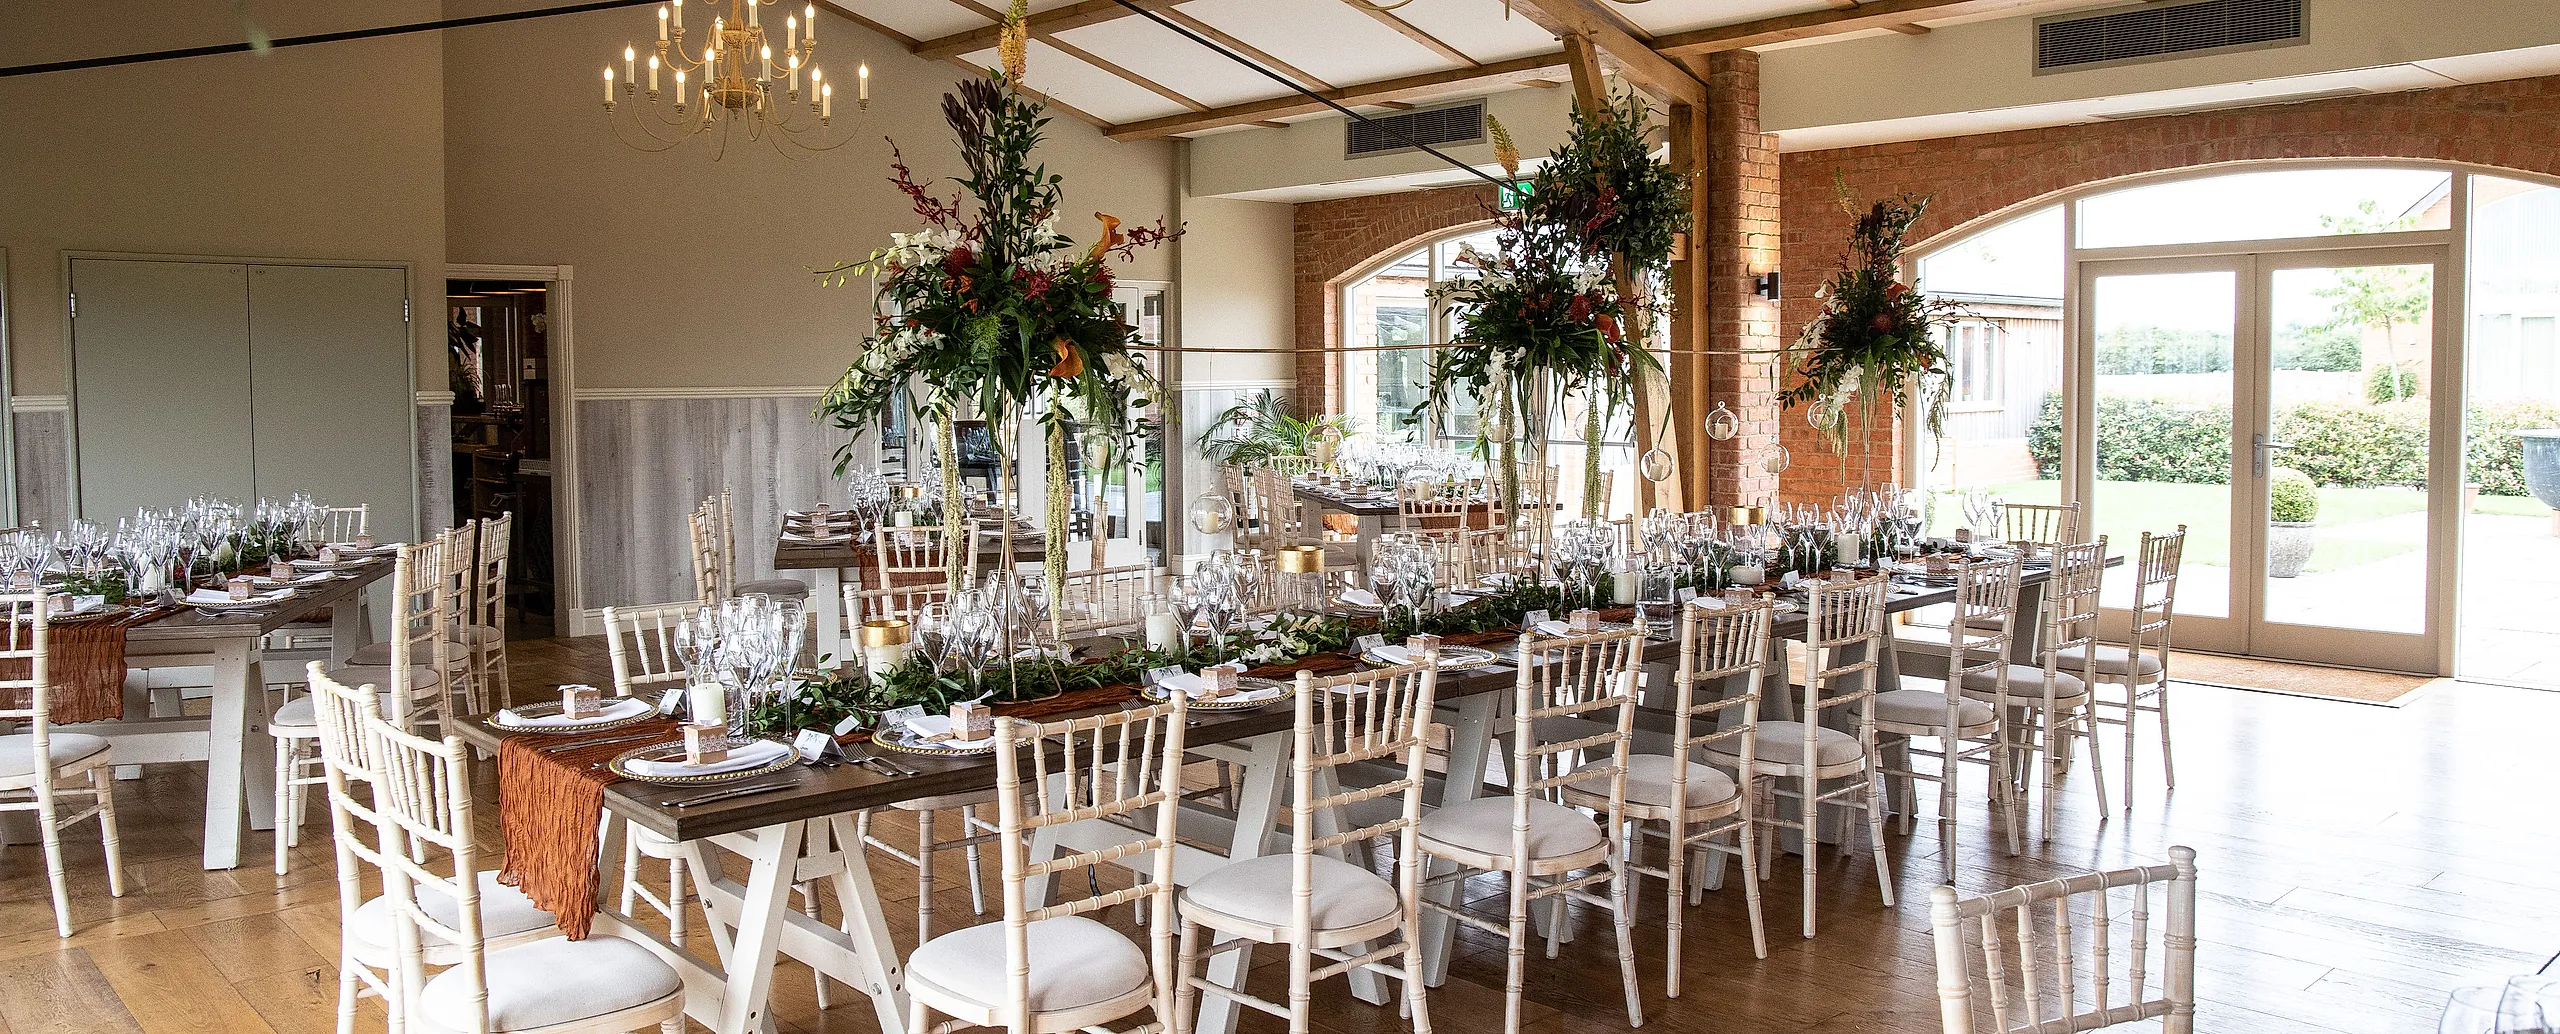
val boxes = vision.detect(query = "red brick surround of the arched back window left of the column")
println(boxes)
[1295,187,1495,410]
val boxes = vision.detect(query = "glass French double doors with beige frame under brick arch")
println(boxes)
[2063,246,2463,673]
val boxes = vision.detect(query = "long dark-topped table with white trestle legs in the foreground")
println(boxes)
[458,560,2099,1034]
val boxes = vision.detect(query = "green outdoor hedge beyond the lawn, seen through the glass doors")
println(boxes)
[2028,394,2560,497]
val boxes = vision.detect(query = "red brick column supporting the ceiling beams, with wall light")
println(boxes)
[1684,51,1781,507]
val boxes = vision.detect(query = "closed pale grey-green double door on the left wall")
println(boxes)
[69,259,417,537]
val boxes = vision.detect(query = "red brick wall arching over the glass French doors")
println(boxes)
[1779,77,2560,502]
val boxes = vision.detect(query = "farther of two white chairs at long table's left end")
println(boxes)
[310,663,558,1034]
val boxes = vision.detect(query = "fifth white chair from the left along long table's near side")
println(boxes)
[1708,573,1894,937]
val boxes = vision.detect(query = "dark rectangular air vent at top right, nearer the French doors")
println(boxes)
[2035,0,2309,74]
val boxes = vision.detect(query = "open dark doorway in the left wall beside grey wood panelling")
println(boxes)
[445,279,561,640]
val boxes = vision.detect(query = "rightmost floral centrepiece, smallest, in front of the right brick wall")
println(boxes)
[1779,179,1966,466]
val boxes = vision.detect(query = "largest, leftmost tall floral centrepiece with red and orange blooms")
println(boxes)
[817,0,1178,599]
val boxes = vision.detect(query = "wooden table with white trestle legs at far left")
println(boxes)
[114,558,392,870]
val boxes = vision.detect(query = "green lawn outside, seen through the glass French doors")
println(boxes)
[1933,481,2550,571]
